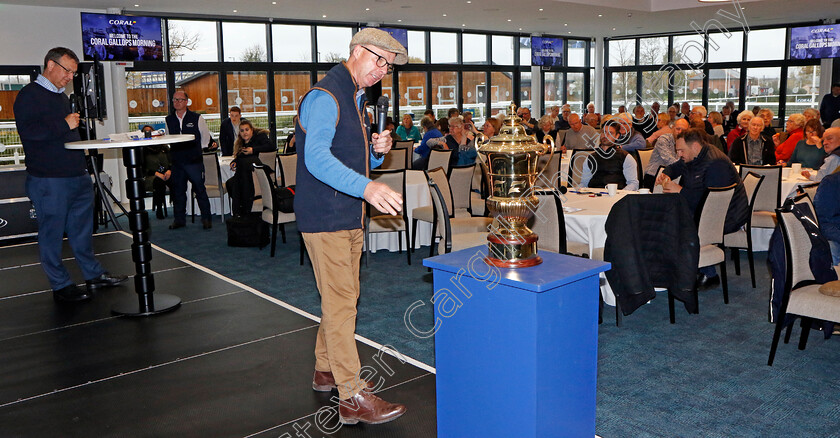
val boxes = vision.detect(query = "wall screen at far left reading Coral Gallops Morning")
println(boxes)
[82,12,163,61]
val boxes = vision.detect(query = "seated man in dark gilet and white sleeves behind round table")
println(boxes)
[580,123,639,190]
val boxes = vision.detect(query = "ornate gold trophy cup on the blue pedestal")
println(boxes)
[476,102,554,268]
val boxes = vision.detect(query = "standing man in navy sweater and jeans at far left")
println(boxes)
[14,47,127,302]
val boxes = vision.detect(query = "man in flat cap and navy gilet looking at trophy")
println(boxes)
[295,28,408,424]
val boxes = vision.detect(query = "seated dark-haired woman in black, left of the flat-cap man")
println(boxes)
[225,119,277,216]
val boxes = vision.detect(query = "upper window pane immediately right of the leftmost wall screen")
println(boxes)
[167,20,219,62]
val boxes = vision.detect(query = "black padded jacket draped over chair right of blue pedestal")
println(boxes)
[604,194,700,315]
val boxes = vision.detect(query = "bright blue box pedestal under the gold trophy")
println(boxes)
[423,247,610,438]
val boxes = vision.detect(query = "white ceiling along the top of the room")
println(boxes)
[0,0,840,36]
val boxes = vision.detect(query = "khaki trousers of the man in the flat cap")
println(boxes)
[303,229,364,400]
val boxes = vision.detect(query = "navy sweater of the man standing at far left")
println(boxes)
[14,82,87,178]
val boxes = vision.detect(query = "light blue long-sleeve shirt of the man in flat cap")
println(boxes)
[300,90,384,198]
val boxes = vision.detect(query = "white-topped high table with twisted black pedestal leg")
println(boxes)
[64,134,195,316]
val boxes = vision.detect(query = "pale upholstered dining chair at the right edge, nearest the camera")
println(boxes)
[767,203,840,366]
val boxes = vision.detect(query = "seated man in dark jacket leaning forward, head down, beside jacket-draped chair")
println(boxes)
[656,128,750,289]
